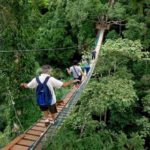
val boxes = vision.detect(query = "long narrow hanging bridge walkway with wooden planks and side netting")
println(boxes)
[2,29,105,150]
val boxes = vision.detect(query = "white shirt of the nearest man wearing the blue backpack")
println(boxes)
[27,74,63,105]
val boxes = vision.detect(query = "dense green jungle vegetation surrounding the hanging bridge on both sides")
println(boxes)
[0,0,150,150]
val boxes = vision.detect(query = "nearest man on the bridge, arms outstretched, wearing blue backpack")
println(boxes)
[20,65,78,124]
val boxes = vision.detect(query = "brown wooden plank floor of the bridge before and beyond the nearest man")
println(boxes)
[2,88,76,150]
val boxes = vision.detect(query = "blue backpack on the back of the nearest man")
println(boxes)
[36,76,52,106]
